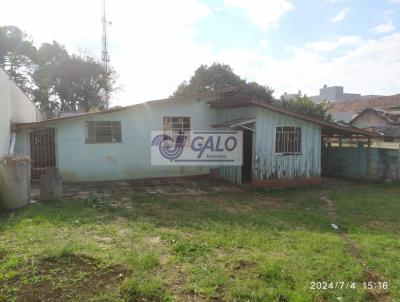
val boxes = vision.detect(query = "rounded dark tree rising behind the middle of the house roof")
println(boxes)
[174,63,273,101]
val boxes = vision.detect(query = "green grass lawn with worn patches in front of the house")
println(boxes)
[0,183,400,302]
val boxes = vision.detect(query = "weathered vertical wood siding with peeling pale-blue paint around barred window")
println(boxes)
[253,108,321,181]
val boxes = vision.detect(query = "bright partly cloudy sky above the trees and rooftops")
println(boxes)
[0,0,400,106]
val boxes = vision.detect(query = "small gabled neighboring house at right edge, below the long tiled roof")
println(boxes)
[349,108,400,148]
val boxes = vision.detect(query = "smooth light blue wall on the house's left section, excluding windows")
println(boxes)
[17,98,216,181]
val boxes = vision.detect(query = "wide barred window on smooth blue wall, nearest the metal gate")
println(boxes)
[85,121,122,144]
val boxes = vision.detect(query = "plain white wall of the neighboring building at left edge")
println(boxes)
[0,68,41,158]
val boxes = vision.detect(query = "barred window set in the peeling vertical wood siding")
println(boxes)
[275,126,301,155]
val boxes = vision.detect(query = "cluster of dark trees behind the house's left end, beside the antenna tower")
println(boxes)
[0,26,115,117]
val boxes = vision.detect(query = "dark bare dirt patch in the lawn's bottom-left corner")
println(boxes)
[13,255,130,302]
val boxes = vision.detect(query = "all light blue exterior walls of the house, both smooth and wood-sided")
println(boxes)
[16,98,321,183]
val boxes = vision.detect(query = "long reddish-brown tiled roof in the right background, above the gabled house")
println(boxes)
[329,94,400,122]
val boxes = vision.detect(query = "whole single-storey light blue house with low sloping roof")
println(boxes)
[14,89,370,186]
